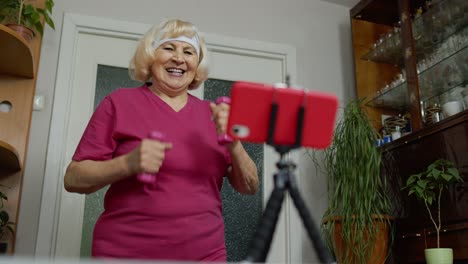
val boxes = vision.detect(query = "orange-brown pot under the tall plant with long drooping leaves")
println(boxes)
[330,215,393,264]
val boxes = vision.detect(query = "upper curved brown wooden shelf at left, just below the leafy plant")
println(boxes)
[0,24,34,78]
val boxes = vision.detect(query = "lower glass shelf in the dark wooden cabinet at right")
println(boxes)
[367,36,468,111]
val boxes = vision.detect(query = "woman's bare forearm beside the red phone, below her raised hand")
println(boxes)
[228,141,258,194]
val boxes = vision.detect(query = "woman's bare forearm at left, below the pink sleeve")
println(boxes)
[64,156,131,194]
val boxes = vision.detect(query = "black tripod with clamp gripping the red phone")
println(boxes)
[244,77,335,264]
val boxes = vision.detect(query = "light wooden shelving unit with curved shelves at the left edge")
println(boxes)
[0,0,44,254]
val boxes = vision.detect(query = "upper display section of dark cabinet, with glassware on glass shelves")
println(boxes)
[352,0,468,142]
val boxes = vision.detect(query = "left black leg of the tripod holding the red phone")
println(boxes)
[245,173,286,262]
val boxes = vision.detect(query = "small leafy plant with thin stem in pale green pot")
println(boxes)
[404,159,463,264]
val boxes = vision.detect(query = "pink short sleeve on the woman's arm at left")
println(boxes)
[72,96,117,161]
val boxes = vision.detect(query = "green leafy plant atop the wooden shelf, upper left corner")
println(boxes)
[0,0,55,42]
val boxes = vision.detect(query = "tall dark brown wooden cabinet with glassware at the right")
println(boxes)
[350,0,468,263]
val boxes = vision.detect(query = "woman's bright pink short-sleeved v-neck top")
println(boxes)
[73,85,230,261]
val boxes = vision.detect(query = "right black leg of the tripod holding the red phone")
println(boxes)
[289,175,335,264]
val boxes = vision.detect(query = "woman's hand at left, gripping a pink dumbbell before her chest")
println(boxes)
[126,139,172,175]
